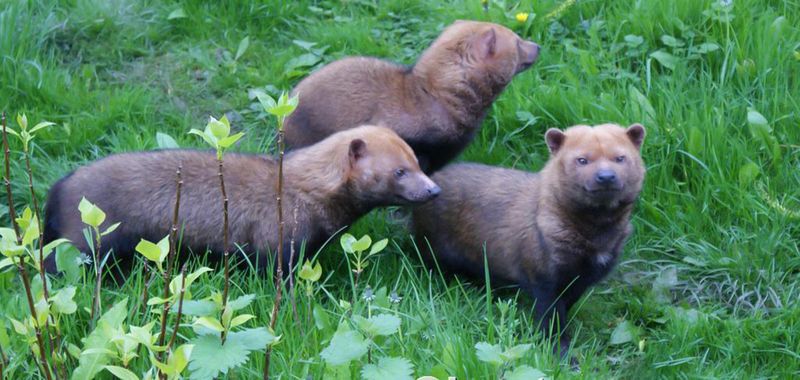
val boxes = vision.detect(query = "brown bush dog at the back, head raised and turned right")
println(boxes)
[286,21,539,173]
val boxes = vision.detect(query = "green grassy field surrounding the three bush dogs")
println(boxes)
[0,0,800,379]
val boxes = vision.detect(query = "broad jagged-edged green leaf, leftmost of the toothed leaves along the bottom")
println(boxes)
[189,327,278,379]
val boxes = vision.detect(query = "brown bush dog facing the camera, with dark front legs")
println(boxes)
[413,124,645,356]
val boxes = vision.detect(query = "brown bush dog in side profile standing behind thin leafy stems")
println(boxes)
[45,126,439,272]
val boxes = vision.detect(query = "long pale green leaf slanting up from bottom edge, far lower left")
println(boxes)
[70,298,128,380]
